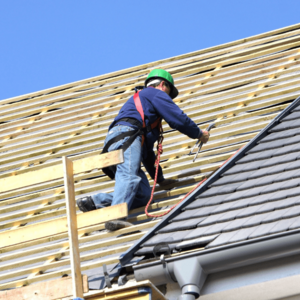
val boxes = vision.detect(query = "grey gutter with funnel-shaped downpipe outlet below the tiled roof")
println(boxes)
[133,229,300,300]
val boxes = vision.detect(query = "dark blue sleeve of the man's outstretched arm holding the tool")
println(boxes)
[152,91,202,139]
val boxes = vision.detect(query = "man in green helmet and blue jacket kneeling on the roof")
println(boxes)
[77,69,209,230]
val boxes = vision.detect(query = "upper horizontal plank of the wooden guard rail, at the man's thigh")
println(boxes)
[0,150,124,193]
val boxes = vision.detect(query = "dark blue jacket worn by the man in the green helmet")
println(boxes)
[109,87,202,182]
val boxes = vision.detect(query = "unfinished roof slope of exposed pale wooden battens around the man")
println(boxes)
[0,24,300,299]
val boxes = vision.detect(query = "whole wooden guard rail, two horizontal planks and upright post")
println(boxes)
[0,150,128,298]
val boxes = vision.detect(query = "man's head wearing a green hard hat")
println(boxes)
[145,69,178,99]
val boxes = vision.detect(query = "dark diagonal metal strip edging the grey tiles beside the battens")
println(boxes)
[119,96,300,266]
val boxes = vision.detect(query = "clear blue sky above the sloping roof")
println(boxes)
[0,0,300,99]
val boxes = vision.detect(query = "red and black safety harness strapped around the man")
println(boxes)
[102,90,163,179]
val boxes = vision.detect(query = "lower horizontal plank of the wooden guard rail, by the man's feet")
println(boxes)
[0,203,128,248]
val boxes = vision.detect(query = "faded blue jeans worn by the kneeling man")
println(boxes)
[92,125,151,209]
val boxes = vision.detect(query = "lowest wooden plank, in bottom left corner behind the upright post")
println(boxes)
[0,275,89,300]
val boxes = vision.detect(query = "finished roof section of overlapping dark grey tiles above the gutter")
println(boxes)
[130,97,300,255]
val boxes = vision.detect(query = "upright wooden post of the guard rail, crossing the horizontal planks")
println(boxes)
[62,156,83,298]
